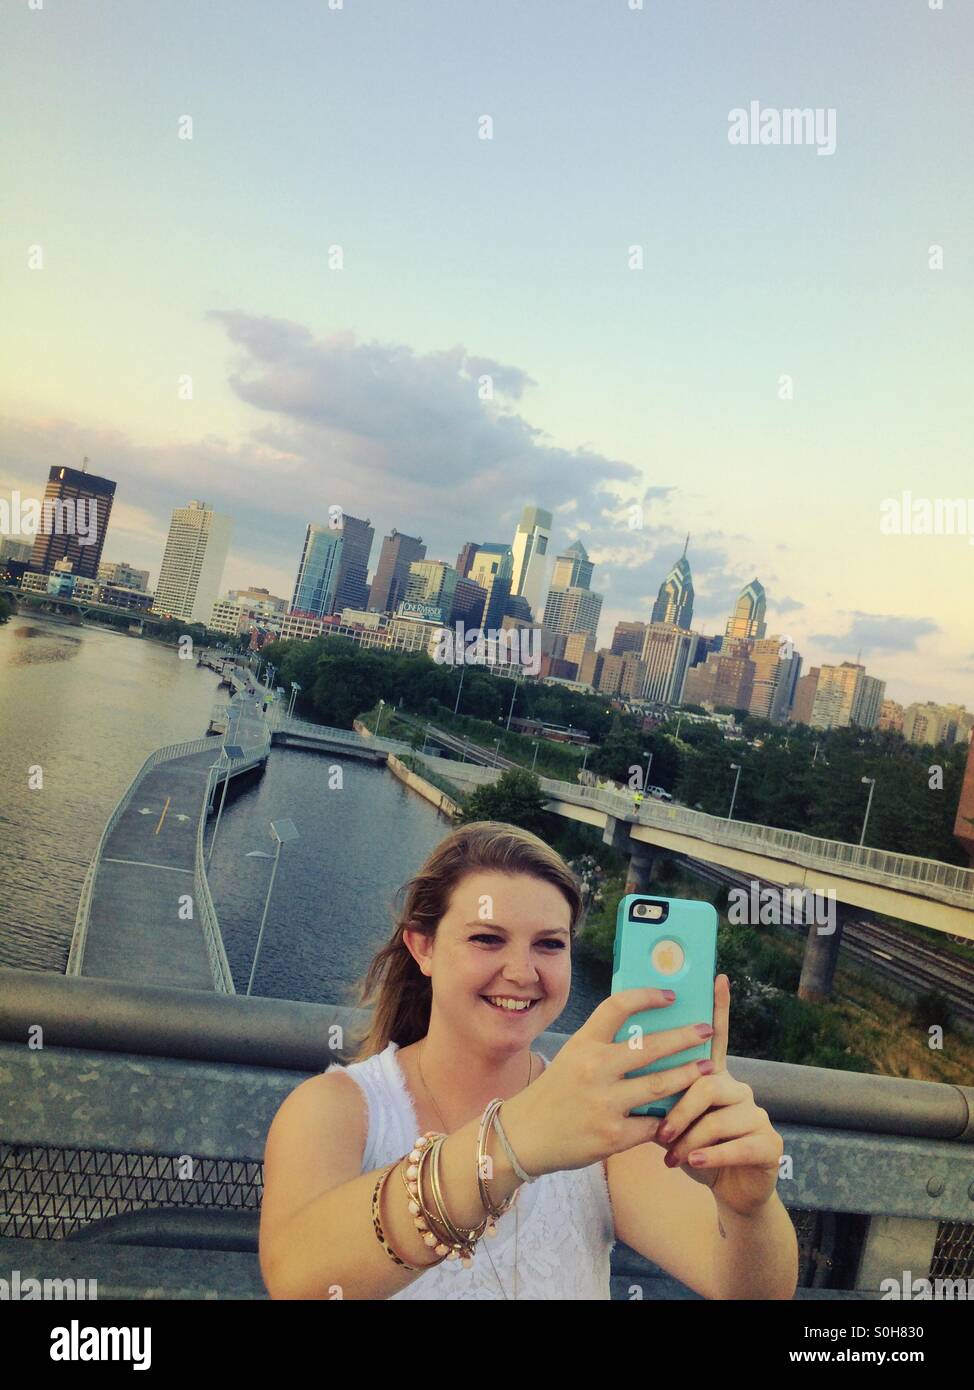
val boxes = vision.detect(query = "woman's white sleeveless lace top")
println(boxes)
[327,1043,616,1301]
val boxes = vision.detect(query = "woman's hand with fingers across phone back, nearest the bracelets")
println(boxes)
[500,988,713,1177]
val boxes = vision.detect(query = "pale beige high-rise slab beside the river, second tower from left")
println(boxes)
[153,502,233,623]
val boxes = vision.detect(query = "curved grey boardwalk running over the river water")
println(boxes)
[67,692,271,994]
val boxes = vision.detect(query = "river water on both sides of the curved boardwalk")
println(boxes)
[0,614,609,1031]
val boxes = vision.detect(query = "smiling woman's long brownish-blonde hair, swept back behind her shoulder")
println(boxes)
[349,820,582,1062]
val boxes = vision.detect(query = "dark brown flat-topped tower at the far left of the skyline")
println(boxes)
[31,459,115,580]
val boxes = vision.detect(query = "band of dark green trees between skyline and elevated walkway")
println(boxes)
[264,638,967,865]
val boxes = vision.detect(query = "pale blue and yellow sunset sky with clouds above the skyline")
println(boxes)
[0,0,974,709]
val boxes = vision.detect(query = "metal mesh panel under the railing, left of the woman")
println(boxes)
[0,1143,263,1240]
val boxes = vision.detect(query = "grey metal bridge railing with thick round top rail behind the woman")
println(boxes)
[0,970,974,1298]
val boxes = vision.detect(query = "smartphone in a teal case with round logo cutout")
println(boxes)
[611,892,717,1118]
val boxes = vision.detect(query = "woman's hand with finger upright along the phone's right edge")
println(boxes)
[653,974,785,1216]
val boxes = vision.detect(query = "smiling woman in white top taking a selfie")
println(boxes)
[260,821,796,1300]
